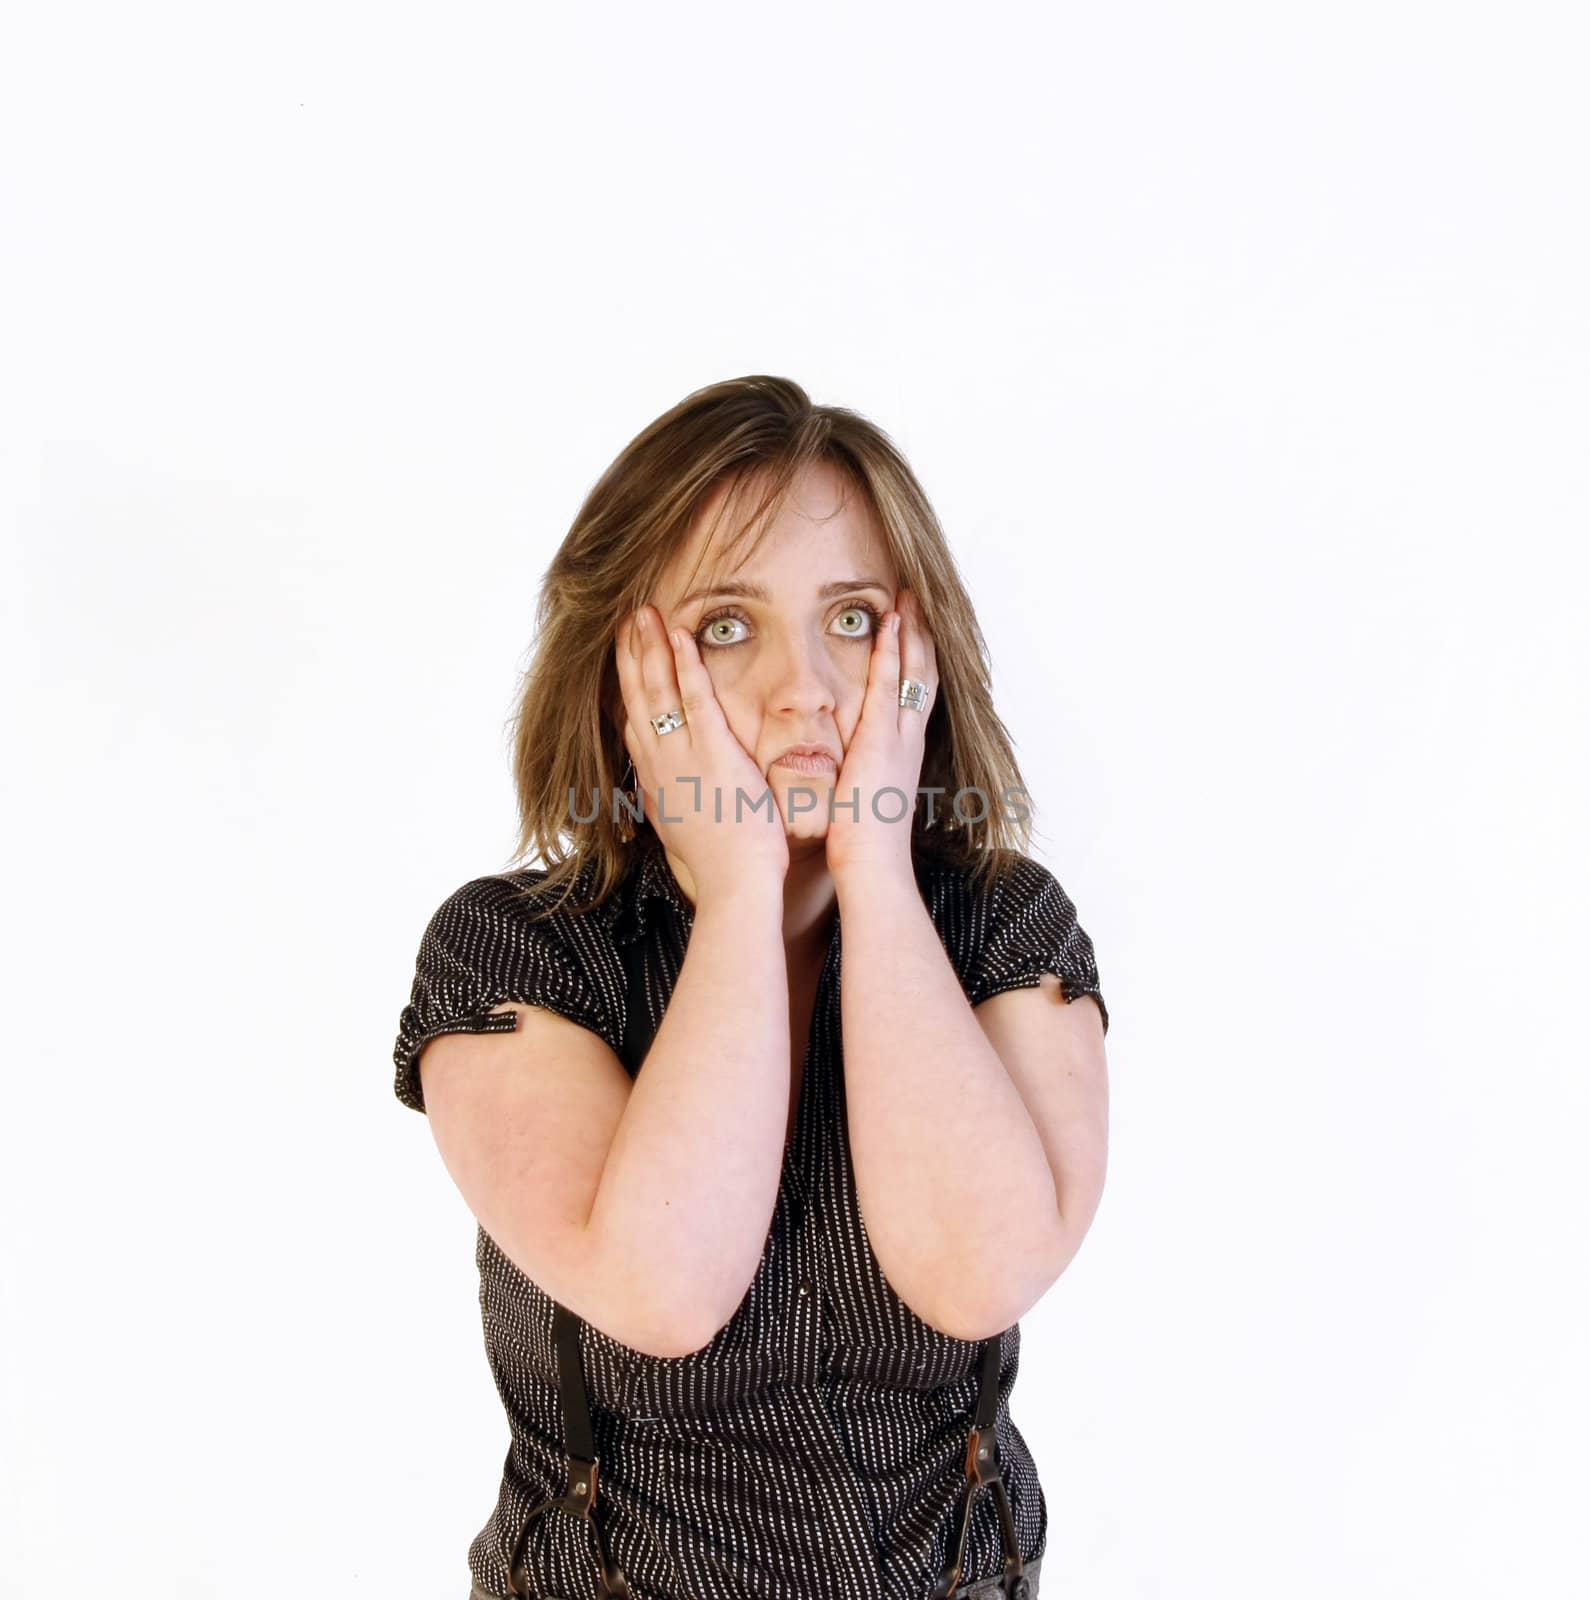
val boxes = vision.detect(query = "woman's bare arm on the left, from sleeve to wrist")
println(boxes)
[419,875,790,1357]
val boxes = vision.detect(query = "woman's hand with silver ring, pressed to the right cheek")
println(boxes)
[827,589,939,877]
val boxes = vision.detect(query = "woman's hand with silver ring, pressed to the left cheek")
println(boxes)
[616,605,790,899]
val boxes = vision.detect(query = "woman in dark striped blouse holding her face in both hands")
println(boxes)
[395,378,1107,1600]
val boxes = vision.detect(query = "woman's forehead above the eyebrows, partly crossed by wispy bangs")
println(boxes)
[659,461,896,603]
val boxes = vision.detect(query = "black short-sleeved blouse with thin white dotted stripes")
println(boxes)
[394,826,1109,1600]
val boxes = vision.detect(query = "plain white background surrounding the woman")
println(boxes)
[0,0,1590,1600]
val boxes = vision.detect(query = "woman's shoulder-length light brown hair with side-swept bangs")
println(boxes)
[513,376,1032,909]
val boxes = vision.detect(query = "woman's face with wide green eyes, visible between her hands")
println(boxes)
[654,462,897,845]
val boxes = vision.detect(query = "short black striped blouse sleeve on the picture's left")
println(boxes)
[392,877,619,1112]
